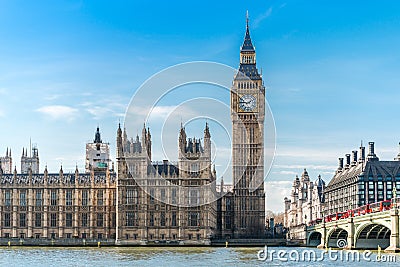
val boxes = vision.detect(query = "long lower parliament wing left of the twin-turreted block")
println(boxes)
[0,127,116,241]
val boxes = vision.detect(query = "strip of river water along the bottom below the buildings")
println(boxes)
[0,246,400,267]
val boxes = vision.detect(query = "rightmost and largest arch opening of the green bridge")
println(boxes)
[355,223,391,249]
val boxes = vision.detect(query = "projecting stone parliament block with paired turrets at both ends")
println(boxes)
[116,125,216,244]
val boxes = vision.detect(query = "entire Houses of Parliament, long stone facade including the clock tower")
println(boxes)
[0,17,265,245]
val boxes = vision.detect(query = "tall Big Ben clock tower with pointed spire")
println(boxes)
[231,13,265,238]
